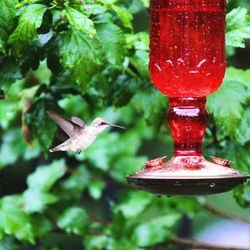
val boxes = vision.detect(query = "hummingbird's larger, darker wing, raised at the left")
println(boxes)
[47,111,84,137]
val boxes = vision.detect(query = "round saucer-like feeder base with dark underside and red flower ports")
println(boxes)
[127,156,250,196]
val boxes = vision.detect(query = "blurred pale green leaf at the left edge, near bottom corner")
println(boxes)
[0,196,34,243]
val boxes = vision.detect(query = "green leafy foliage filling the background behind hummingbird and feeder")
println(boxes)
[0,0,250,250]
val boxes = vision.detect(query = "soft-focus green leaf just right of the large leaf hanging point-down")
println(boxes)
[96,23,125,65]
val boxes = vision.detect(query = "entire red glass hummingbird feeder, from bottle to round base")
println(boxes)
[128,0,249,195]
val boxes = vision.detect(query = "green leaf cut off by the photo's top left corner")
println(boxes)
[0,0,18,52]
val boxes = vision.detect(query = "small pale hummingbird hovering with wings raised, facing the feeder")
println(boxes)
[47,111,125,154]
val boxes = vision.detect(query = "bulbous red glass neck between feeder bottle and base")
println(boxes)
[167,97,208,156]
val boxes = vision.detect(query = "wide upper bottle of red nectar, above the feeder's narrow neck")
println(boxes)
[150,0,226,97]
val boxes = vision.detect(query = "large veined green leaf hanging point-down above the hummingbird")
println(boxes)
[60,30,100,93]
